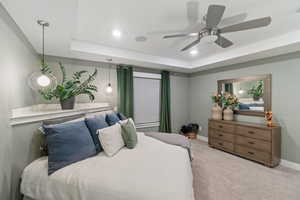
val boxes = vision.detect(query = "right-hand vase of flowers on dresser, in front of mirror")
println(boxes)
[221,93,240,121]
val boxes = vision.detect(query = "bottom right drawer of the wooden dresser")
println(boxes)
[235,145,271,163]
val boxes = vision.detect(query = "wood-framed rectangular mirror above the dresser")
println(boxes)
[218,74,272,117]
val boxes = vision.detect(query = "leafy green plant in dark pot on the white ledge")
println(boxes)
[39,63,97,110]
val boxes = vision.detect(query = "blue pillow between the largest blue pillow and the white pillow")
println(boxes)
[85,115,108,153]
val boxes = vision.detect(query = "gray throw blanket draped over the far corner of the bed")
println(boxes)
[145,132,192,161]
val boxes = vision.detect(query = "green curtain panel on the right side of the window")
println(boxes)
[159,71,172,133]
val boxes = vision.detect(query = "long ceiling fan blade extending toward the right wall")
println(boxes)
[220,17,272,33]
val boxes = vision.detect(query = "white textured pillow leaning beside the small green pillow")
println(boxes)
[98,124,125,157]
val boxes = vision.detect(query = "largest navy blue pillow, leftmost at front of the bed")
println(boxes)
[43,120,96,175]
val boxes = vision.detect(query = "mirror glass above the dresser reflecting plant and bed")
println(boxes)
[222,80,264,112]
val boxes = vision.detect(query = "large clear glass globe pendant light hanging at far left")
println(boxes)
[28,20,57,91]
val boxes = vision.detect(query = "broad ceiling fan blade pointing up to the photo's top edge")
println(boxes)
[206,5,225,28]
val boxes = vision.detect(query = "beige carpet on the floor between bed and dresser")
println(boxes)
[192,140,300,200]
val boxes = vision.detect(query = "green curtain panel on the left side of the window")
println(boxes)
[117,66,134,118]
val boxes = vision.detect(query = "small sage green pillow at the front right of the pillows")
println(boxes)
[121,119,137,149]
